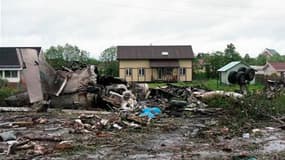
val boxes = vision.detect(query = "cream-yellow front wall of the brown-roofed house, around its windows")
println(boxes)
[119,60,192,82]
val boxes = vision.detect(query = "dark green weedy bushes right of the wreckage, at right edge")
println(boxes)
[205,90,285,133]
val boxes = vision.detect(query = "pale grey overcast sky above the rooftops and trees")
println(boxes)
[0,0,285,57]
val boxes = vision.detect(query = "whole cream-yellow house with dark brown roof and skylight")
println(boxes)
[117,46,194,82]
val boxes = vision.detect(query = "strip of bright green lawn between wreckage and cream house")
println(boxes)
[149,79,264,91]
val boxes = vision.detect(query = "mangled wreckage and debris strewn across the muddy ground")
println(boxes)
[0,50,285,160]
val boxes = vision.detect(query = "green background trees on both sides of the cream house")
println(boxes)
[44,43,285,78]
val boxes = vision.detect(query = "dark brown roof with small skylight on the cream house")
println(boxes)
[117,45,194,60]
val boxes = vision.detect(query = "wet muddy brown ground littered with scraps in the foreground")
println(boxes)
[0,110,285,160]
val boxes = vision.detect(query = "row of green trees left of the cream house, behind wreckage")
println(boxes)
[44,43,119,77]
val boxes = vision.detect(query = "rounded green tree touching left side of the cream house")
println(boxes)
[99,46,119,76]
